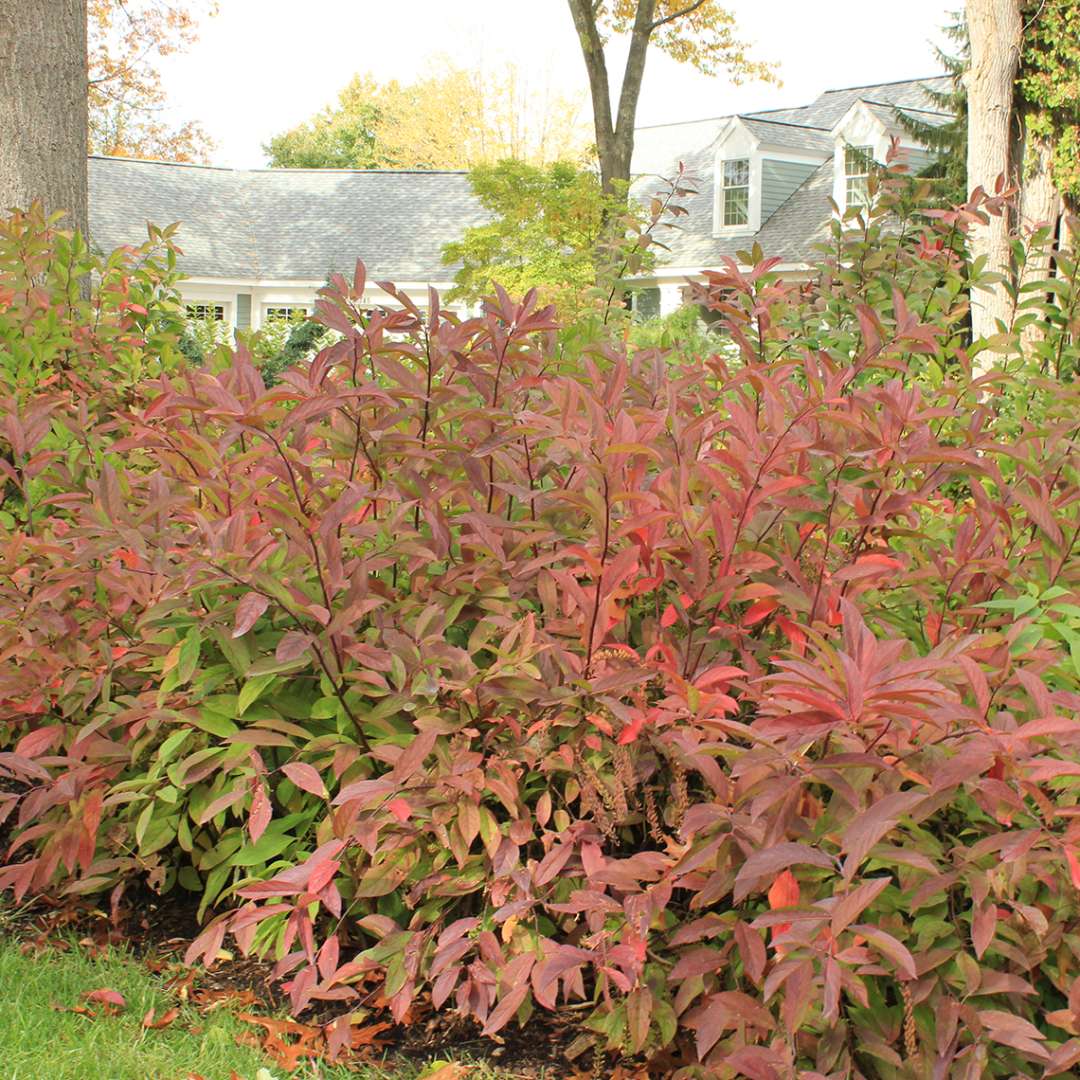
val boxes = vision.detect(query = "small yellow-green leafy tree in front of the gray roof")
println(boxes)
[443,161,612,315]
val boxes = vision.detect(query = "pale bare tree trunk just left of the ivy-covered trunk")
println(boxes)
[966,0,1022,338]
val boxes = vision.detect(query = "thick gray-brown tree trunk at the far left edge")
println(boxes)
[0,0,87,234]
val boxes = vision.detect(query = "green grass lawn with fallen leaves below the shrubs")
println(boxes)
[0,940,522,1080]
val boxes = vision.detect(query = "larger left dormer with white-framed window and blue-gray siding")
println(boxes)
[713,117,833,237]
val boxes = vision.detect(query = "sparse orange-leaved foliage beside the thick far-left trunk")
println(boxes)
[86,0,216,161]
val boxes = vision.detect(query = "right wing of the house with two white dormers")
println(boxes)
[633,77,953,314]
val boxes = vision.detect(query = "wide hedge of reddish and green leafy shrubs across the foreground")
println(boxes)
[0,181,1080,1080]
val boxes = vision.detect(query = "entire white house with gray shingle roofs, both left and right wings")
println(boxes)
[90,77,950,329]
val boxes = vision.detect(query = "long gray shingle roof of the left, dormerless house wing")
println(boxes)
[90,157,487,282]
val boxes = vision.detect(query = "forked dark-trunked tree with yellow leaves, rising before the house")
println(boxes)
[567,0,775,192]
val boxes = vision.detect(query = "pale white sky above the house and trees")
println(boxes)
[162,0,960,168]
